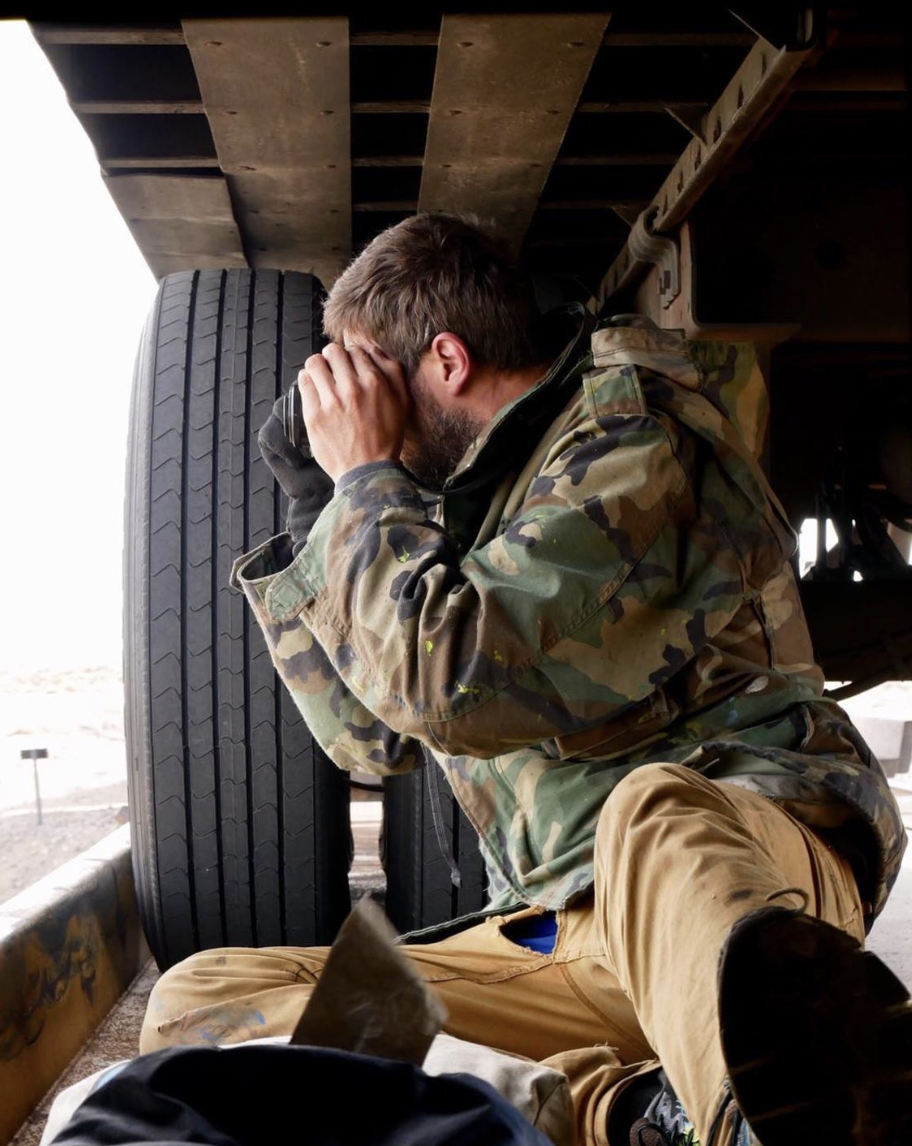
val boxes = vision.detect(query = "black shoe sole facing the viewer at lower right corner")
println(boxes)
[720,909,912,1146]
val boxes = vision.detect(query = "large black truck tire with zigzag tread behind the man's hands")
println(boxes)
[124,269,351,968]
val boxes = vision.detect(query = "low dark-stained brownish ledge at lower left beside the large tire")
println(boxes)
[0,825,149,1146]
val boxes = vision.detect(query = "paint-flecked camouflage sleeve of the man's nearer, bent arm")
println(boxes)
[234,402,744,758]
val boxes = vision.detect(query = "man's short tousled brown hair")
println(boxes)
[323,214,542,376]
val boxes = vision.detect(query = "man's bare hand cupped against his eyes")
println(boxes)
[298,343,409,481]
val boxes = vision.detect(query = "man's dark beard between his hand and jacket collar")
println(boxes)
[401,372,485,489]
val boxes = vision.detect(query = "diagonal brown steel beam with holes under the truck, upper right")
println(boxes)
[588,40,812,313]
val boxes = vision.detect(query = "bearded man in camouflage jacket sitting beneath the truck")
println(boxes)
[142,215,912,1146]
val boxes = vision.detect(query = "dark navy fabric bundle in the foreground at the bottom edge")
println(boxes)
[54,1043,550,1146]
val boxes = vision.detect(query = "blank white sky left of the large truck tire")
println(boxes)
[0,21,156,673]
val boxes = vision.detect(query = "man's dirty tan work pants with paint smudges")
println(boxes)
[141,764,864,1146]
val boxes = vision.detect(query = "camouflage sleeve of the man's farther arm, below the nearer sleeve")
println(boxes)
[231,534,424,776]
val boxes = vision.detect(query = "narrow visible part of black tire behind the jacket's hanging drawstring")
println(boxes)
[384,760,487,932]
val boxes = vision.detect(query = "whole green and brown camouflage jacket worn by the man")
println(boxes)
[233,308,905,923]
